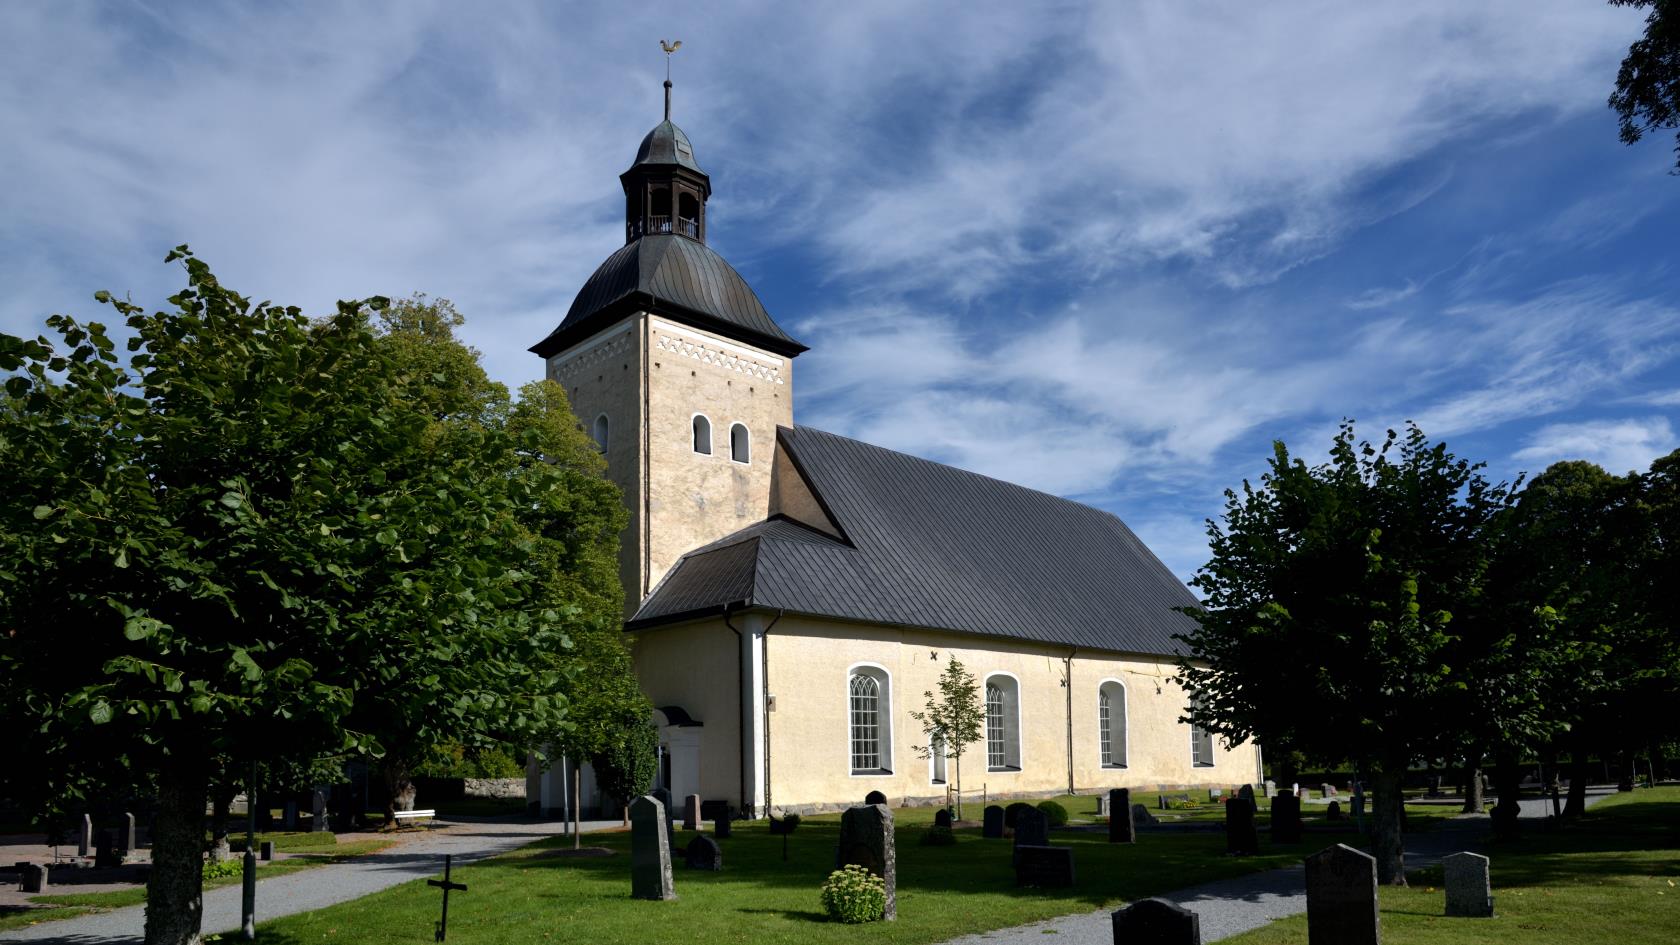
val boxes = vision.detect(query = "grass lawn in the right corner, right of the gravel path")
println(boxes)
[1228,787,1680,945]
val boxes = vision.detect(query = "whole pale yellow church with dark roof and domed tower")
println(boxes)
[531,81,1260,816]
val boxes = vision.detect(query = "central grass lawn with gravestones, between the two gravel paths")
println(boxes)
[248,797,1370,945]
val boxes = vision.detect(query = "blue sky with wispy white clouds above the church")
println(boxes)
[0,0,1680,577]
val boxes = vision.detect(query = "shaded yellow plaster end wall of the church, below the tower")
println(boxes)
[632,620,741,804]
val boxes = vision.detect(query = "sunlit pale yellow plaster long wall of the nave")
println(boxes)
[766,615,1257,807]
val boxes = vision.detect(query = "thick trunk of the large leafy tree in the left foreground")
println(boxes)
[146,757,210,945]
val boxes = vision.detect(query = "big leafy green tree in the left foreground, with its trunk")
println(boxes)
[0,247,575,945]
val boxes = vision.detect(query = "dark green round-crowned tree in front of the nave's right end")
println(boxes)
[1178,424,1510,884]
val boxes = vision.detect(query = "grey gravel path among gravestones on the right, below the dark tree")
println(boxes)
[944,787,1616,945]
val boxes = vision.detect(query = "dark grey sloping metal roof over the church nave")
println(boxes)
[630,427,1196,656]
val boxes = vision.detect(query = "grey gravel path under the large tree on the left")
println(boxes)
[0,821,620,945]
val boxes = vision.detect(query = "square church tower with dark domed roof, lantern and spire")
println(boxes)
[531,79,805,614]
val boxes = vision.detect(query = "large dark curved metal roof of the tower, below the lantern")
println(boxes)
[531,233,805,358]
